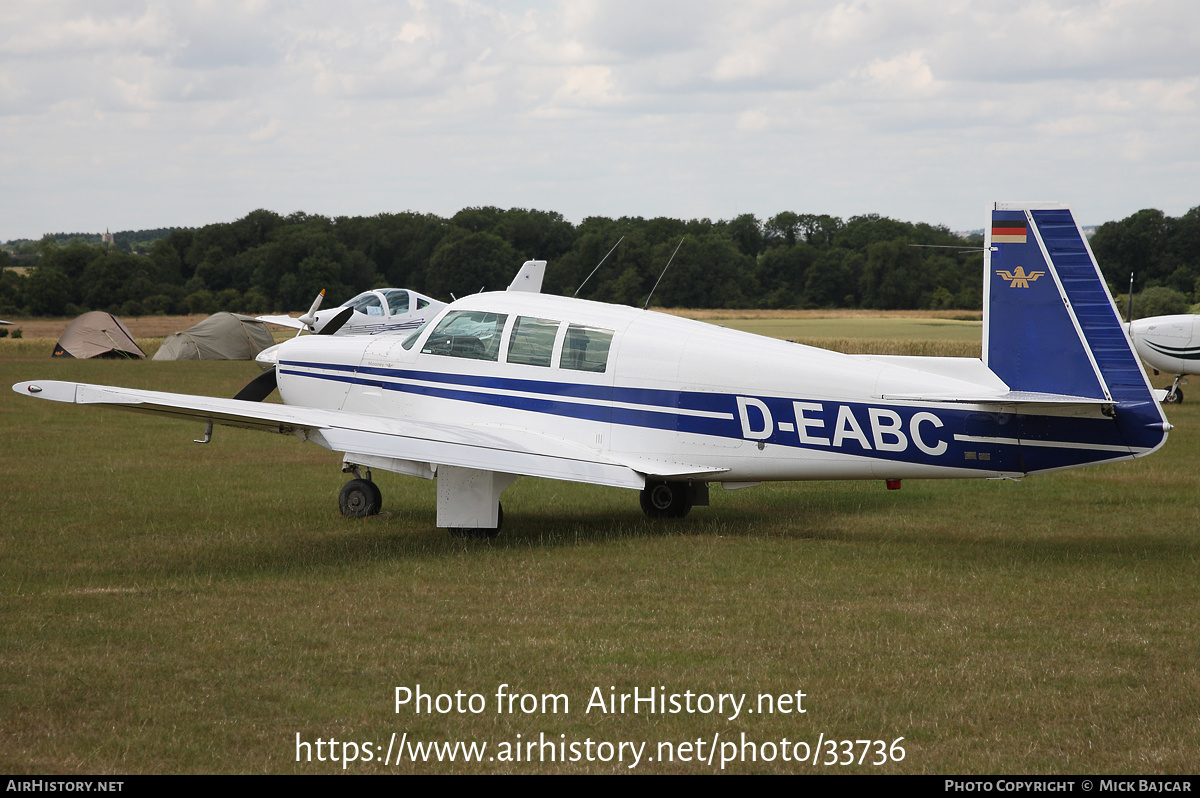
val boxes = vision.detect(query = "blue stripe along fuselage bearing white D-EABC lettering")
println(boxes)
[280,361,1124,473]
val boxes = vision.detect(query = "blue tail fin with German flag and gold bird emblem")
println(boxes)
[984,203,1170,449]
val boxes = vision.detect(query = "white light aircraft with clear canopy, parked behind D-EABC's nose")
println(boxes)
[258,288,445,335]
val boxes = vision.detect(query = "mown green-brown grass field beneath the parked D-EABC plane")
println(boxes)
[0,319,1200,773]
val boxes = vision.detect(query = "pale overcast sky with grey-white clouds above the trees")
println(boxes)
[0,0,1200,240]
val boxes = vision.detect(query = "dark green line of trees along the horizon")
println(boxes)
[0,202,1200,317]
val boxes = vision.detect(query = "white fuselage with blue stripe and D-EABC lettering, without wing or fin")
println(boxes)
[276,293,1160,482]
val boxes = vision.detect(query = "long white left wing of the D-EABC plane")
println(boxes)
[13,380,725,490]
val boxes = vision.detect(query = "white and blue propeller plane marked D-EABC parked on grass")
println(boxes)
[13,203,1170,536]
